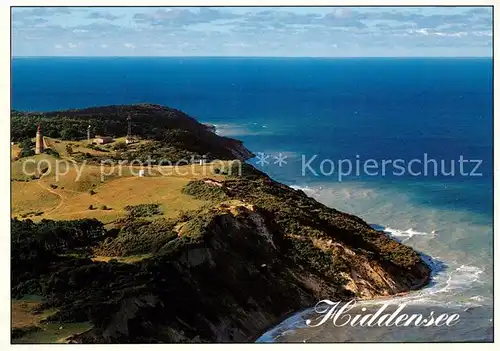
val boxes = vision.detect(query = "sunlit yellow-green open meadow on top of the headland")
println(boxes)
[11,144,235,223]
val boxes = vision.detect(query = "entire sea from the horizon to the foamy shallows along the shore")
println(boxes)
[12,58,493,342]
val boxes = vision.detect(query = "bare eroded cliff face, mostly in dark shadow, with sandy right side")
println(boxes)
[68,192,429,342]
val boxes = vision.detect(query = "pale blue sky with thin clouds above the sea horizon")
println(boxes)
[11,7,493,57]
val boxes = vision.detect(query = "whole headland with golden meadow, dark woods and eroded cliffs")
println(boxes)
[11,105,430,343]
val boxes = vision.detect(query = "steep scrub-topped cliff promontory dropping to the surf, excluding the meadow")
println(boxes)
[55,170,430,342]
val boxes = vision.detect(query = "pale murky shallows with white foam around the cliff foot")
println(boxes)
[256,183,491,341]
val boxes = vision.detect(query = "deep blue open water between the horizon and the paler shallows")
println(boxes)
[12,58,493,216]
